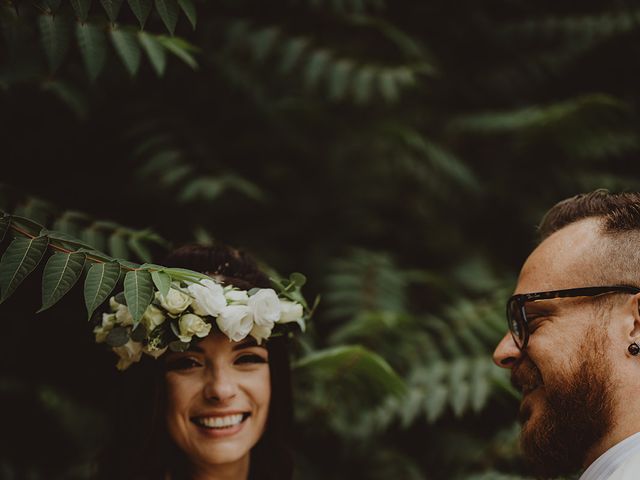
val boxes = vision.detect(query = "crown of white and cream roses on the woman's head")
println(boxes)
[93,278,309,370]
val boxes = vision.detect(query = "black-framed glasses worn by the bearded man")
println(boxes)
[507,285,640,351]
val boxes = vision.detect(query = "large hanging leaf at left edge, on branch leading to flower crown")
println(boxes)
[0,237,49,303]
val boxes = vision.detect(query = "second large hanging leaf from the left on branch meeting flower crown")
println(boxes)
[38,253,85,312]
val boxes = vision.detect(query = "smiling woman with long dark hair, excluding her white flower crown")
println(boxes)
[96,246,300,480]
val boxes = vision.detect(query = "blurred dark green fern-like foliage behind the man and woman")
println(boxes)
[0,0,640,479]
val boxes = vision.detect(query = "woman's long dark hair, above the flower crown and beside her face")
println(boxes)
[100,245,293,480]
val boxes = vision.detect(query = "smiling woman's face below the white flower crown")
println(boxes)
[165,333,271,468]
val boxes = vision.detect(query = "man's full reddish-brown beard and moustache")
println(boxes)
[511,342,613,478]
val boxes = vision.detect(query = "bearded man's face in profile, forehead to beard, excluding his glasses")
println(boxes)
[494,220,613,477]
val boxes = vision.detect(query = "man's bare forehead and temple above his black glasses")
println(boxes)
[516,218,603,293]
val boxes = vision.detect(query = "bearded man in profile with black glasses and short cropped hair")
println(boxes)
[494,190,640,480]
